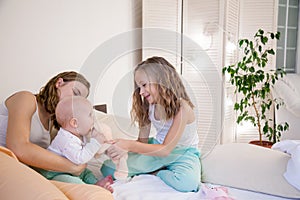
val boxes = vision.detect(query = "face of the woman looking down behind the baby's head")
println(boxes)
[56,78,89,99]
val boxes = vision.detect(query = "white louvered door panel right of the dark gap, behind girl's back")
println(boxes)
[182,0,223,155]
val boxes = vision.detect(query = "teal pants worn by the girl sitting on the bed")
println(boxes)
[100,139,201,192]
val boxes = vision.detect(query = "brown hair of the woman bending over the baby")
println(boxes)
[36,71,90,128]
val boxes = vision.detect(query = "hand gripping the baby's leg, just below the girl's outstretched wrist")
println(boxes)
[106,139,130,161]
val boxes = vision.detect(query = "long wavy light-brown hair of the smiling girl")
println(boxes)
[131,56,194,127]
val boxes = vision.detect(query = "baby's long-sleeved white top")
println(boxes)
[48,128,101,164]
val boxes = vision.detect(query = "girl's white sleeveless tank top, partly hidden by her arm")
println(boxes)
[149,105,199,148]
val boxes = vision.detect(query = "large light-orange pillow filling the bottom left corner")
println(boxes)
[0,147,68,200]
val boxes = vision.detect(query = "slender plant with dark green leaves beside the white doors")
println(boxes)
[222,29,289,145]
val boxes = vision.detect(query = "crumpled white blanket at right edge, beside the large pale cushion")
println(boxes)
[272,140,300,190]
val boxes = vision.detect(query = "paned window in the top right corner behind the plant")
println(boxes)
[276,0,299,73]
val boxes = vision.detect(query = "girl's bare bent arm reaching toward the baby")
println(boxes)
[116,102,195,157]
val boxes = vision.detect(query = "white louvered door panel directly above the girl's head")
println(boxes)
[142,0,181,71]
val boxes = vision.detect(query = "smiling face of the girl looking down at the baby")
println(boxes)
[134,70,159,104]
